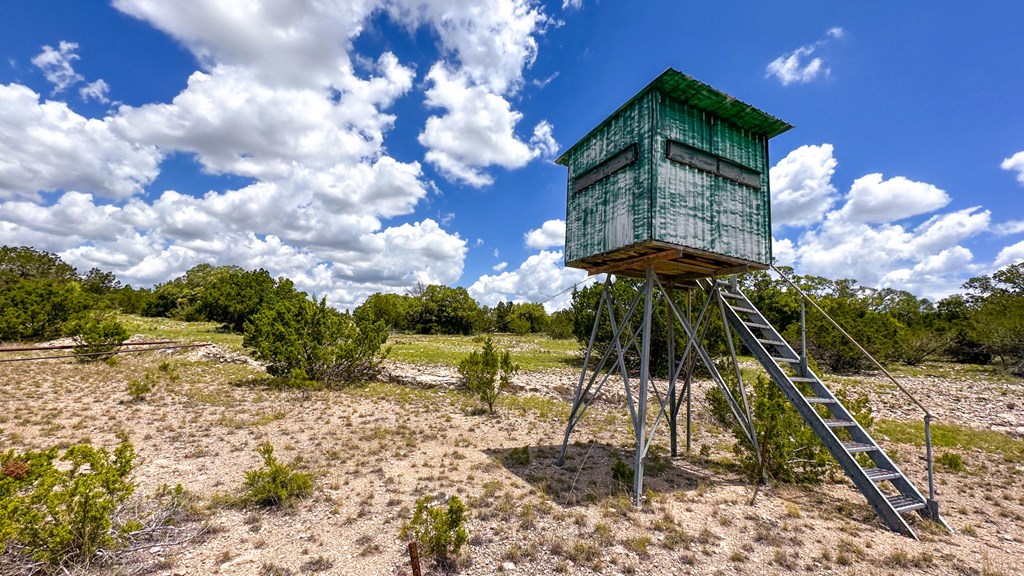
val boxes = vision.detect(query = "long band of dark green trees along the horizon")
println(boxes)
[0,246,1024,377]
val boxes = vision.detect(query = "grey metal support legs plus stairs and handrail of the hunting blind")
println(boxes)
[558,262,949,537]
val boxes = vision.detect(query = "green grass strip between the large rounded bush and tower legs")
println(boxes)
[387,334,583,370]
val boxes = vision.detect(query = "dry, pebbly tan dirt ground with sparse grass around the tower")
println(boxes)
[0,346,1024,576]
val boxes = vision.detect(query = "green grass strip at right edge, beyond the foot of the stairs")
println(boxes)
[874,420,1024,462]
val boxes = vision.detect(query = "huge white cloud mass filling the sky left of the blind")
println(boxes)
[0,0,559,307]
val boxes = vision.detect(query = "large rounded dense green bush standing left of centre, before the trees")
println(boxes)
[243,298,388,384]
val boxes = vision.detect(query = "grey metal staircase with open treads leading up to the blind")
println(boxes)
[710,281,942,538]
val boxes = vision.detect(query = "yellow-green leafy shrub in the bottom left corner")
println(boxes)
[0,439,135,568]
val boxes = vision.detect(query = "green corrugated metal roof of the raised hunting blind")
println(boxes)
[555,68,793,166]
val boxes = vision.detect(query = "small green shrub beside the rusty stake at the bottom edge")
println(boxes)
[399,496,469,570]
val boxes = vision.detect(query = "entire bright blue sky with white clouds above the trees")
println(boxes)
[0,0,1024,307]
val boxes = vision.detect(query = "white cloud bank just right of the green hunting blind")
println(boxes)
[771,145,995,299]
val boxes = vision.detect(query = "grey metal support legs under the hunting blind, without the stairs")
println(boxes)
[557,264,760,506]
